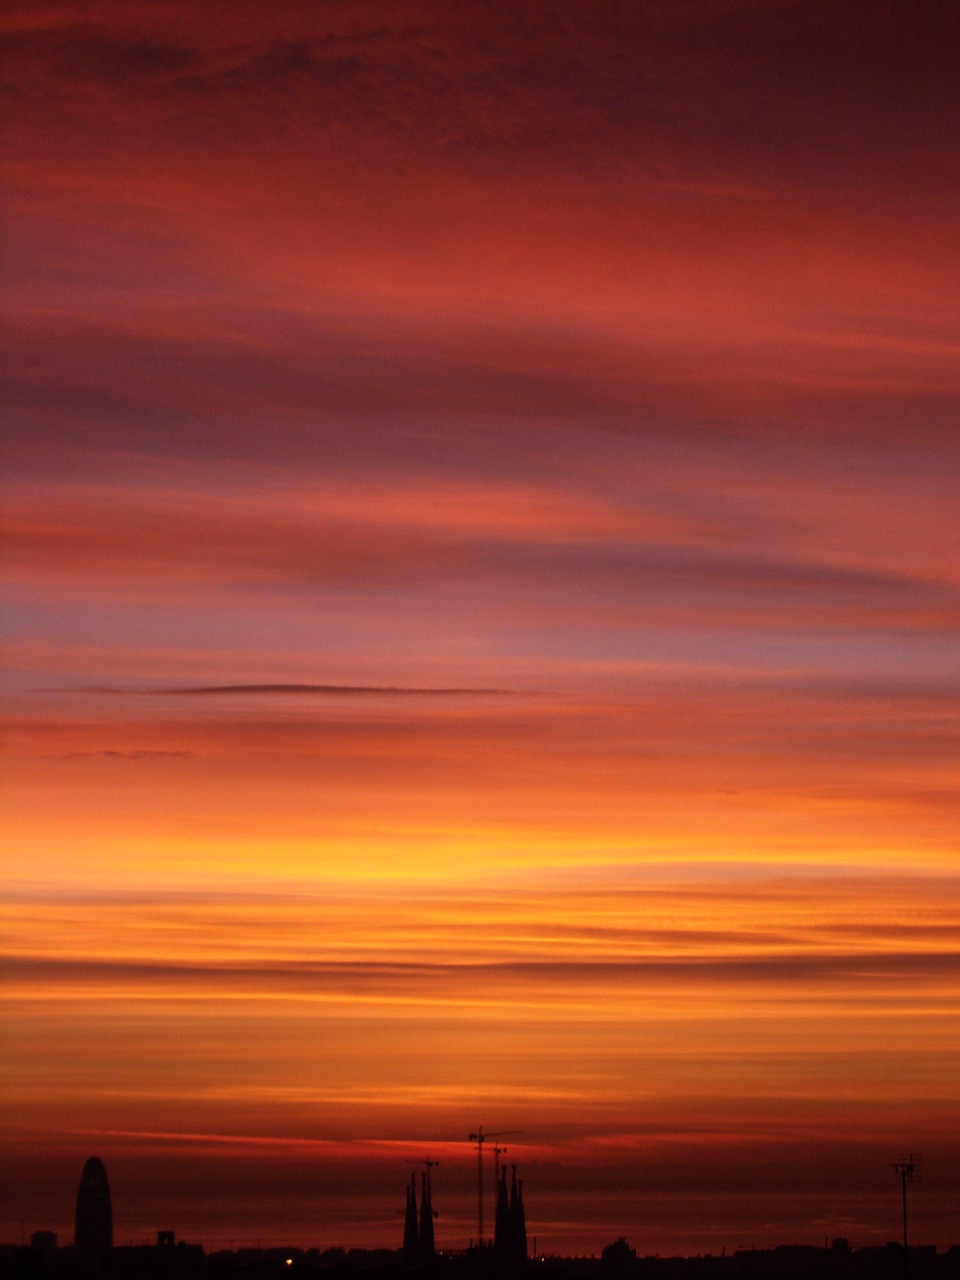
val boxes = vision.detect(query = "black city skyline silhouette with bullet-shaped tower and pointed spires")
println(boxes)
[0,1134,960,1264]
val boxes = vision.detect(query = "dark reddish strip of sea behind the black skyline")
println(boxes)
[92,1175,960,1256]
